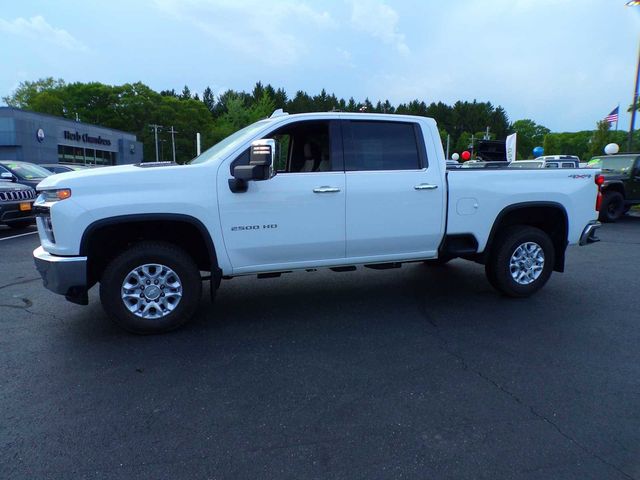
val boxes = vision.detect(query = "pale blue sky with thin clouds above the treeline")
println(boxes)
[0,0,640,131]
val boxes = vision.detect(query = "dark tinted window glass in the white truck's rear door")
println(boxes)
[343,120,426,171]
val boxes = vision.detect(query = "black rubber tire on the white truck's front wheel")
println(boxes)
[100,242,202,334]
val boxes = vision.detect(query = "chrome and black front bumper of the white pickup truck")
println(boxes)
[33,247,87,305]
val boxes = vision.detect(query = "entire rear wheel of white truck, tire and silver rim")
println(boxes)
[485,225,555,297]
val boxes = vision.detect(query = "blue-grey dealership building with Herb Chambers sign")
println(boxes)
[0,107,142,165]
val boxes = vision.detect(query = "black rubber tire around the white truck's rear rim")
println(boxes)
[485,225,555,297]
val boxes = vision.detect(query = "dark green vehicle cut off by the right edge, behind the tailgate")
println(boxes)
[587,153,640,222]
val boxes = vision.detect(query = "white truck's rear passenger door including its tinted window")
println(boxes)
[342,120,446,262]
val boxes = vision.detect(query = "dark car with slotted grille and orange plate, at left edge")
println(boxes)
[0,172,36,228]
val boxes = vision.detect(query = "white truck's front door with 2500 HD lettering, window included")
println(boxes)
[218,121,345,273]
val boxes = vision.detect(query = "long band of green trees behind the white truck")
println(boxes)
[12,77,628,162]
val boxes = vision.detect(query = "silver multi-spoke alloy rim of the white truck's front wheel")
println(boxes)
[120,263,182,319]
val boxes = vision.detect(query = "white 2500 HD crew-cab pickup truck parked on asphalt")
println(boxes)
[34,112,599,333]
